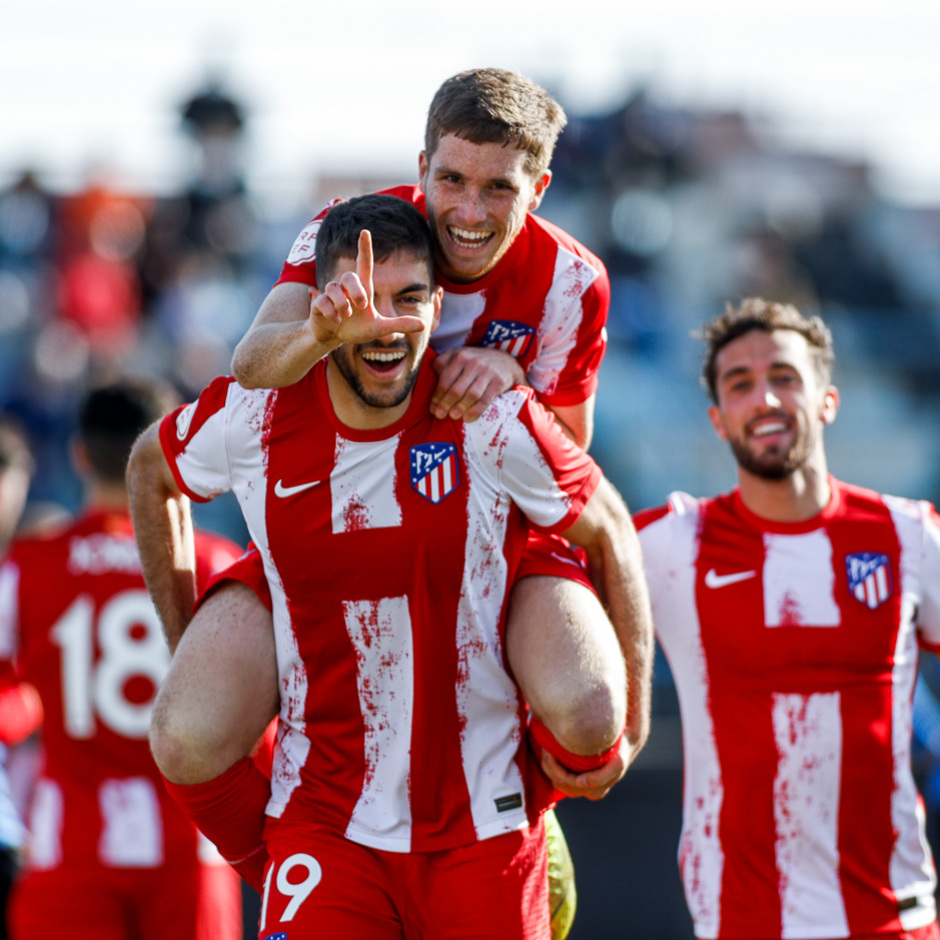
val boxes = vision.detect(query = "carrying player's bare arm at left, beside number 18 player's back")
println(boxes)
[127,428,196,652]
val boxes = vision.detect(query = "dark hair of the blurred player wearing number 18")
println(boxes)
[78,378,179,483]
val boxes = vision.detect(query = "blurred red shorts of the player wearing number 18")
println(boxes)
[7,863,242,940]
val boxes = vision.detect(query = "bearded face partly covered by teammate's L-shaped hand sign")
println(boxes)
[331,251,443,409]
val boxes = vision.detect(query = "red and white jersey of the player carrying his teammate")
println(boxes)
[161,354,600,852]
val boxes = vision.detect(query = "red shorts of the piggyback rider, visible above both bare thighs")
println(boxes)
[196,532,596,610]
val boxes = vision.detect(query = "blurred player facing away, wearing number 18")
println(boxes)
[0,380,242,940]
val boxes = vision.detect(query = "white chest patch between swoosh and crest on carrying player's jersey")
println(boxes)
[330,434,401,534]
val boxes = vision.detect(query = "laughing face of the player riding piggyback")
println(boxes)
[418,134,551,282]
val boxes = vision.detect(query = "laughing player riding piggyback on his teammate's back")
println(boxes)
[160,69,650,797]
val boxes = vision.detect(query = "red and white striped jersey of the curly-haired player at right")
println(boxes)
[637,480,940,938]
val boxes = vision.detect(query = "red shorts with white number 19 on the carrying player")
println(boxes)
[258,820,551,940]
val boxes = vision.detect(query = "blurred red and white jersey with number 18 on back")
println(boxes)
[0,511,241,872]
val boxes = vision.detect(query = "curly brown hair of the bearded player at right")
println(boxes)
[699,297,835,404]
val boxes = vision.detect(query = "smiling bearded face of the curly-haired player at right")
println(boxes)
[709,329,839,480]
